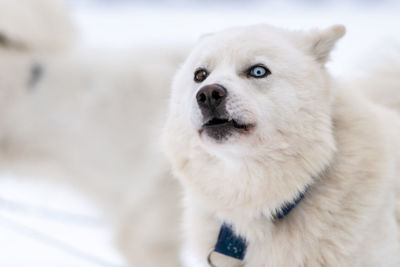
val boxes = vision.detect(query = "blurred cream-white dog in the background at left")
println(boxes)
[0,0,184,267]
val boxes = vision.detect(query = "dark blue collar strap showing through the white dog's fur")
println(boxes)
[208,186,309,266]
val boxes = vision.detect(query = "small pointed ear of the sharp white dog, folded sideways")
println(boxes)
[307,25,346,64]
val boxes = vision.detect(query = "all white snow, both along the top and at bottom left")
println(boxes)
[0,0,400,267]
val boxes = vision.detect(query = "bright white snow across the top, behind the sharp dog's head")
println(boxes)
[72,1,400,75]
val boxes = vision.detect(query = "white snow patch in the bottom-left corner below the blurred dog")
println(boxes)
[0,174,123,267]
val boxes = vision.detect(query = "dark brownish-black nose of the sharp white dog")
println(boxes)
[196,84,228,111]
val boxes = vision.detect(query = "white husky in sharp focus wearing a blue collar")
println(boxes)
[164,25,400,267]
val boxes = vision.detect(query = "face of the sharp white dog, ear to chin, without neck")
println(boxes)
[166,25,343,153]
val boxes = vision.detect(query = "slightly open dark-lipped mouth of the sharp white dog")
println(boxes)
[200,117,254,141]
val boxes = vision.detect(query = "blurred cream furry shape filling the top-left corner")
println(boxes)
[0,0,76,53]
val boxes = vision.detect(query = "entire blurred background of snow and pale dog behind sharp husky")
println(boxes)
[0,0,400,267]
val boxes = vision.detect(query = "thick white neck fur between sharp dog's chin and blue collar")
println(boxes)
[179,134,335,266]
